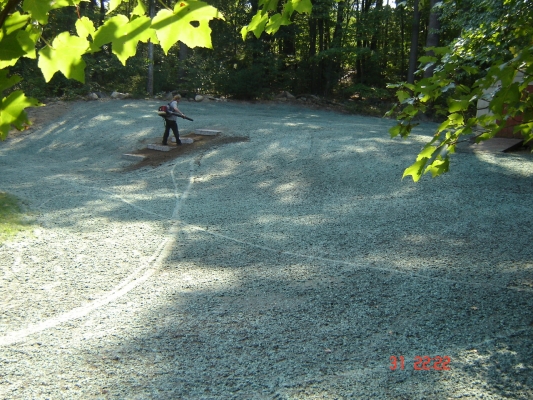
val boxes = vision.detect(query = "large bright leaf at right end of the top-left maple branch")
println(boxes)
[152,1,224,54]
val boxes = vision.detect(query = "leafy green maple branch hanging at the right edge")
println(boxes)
[388,0,533,182]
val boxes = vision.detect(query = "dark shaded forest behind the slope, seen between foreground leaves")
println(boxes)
[7,0,454,115]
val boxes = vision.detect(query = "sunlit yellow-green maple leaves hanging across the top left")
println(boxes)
[0,0,311,140]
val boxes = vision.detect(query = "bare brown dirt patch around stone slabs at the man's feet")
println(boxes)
[123,133,250,172]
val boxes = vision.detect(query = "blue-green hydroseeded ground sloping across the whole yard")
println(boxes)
[0,101,533,399]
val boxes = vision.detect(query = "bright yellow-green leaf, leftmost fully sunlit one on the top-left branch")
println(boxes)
[37,32,89,83]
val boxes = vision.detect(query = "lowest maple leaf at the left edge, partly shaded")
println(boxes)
[0,90,39,140]
